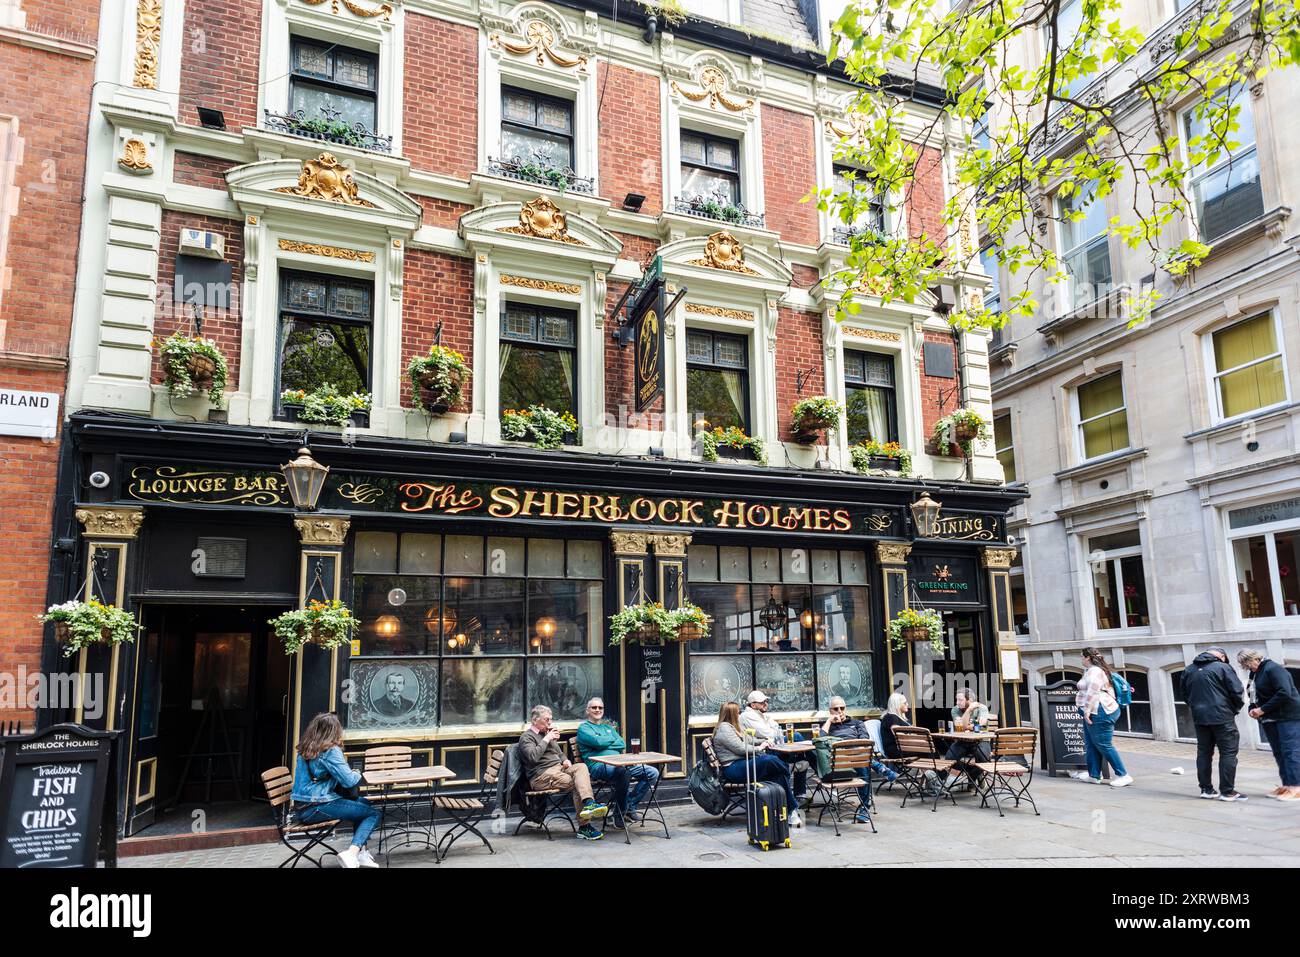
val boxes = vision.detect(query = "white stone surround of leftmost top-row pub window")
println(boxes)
[257,0,404,156]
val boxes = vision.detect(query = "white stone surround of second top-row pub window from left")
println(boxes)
[478,4,601,187]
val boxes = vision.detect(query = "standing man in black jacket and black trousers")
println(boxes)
[1180,648,1245,801]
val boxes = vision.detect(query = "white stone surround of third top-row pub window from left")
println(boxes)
[663,53,767,221]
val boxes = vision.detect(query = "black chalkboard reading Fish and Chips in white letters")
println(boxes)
[0,724,117,869]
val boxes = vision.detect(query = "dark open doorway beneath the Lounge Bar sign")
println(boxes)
[127,605,290,835]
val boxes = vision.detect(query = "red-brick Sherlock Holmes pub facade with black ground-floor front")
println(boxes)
[44,0,1021,833]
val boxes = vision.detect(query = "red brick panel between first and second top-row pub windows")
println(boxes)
[402,14,478,179]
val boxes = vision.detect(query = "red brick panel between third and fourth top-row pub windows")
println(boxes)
[763,103,819,246]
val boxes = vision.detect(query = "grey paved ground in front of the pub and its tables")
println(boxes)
[120,740,1300,869]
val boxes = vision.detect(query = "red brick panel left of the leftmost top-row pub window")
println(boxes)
[181,0,261,130]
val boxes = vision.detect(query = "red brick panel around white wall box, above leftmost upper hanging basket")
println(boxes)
[151,209,243,391]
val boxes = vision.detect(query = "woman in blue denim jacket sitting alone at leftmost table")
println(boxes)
[293,714,380,867]
